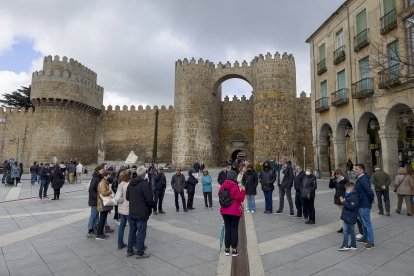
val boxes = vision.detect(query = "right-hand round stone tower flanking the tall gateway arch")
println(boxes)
[250,53,297,162]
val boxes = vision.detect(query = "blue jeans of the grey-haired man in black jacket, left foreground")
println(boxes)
[127,217,147,255]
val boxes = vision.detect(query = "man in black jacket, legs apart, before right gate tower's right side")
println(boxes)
[275,157,295,216]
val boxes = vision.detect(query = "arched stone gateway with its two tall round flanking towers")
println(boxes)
[172,53,297,166]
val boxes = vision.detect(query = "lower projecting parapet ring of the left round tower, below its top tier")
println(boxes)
[32,69,104,93]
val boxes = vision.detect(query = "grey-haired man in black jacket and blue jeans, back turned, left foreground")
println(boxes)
[126,166,155,259]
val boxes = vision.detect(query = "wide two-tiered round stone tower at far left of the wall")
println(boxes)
[30,56,103,164]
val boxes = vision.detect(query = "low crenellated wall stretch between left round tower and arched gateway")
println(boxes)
[102,106,174,163]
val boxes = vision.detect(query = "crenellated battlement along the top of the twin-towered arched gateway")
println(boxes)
[175,52,295,69]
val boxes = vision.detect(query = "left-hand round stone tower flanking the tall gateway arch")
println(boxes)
[172,59,220,166]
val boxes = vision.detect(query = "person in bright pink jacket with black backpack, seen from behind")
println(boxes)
[218,170,246,257]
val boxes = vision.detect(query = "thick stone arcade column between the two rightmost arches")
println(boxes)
[378,129,399,180]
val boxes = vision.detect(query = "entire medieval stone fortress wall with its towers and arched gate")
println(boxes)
[0,53,313,167]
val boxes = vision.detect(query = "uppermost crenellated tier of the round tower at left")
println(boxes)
[43,55,97,82]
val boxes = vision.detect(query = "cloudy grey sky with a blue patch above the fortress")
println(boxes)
[0,0,344,106]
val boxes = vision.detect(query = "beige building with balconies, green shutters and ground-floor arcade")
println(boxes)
[306,0,414,179]
